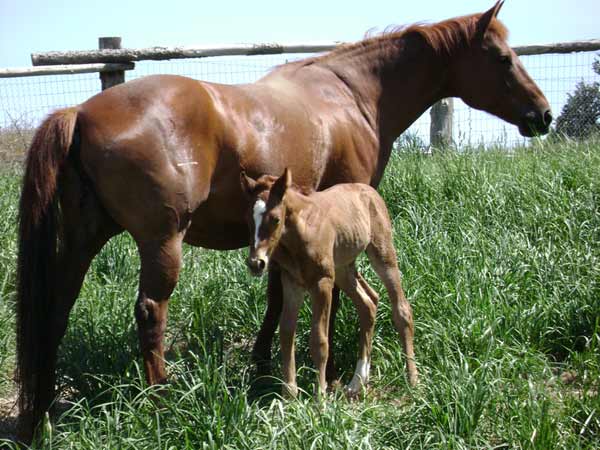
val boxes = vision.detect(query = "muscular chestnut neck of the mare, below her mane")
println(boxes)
[323,33,449,150]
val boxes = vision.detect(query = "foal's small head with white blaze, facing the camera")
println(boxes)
[240,169,292,276]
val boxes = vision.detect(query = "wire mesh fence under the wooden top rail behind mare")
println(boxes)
[0,52,600,147]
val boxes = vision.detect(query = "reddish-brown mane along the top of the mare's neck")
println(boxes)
[292,14,508,66]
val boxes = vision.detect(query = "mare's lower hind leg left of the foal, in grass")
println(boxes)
[135,233,183,384]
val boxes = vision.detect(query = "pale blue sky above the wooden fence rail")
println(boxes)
[0,0,600,67]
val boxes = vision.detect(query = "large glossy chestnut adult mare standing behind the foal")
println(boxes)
[16,2,552,439]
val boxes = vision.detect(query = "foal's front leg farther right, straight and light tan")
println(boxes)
[310,277,334,394]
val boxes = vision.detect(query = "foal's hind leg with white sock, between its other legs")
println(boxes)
[335,265,378,396]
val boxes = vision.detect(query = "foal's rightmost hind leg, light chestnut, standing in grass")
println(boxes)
[367,243,418,386]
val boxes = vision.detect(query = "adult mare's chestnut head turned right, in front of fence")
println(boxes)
[440,1,552,137]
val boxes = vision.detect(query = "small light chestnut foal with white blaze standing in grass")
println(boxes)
[241,168,417,397]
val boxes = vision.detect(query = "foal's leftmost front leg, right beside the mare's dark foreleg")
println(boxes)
[279,274,304,398]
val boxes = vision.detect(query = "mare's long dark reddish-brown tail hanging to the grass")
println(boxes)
[16,108,77,435]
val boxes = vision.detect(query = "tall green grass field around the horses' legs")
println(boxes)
[0,139,600,450]
